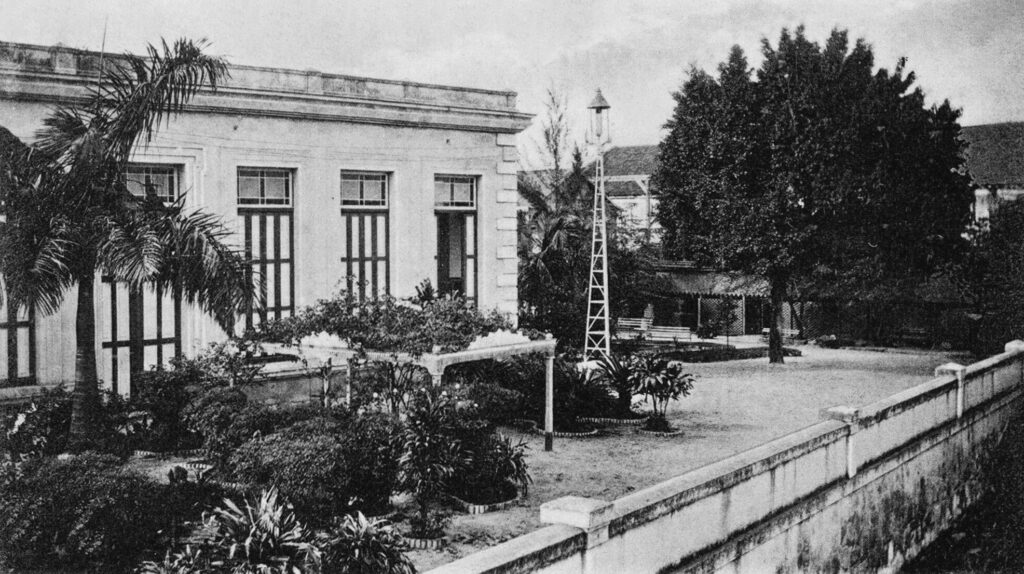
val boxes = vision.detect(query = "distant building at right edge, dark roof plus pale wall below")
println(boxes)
[964,122,1024,221]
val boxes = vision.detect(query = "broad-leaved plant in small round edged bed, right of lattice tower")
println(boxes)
[629,354,693,434]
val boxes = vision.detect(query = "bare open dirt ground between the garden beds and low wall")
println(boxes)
[410,346,969,572]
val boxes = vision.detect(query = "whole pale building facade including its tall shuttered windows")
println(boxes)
[0,43,530,393]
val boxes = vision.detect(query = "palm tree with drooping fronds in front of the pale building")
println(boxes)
[0,39,255,441]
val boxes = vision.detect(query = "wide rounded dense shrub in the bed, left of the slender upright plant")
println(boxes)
[230,415,398,522]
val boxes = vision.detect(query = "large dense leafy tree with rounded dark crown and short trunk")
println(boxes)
[654,28,973,362]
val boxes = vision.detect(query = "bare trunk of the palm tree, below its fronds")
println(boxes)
[69,271,99,448]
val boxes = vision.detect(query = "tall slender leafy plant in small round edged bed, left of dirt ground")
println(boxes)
[398,388,462,547]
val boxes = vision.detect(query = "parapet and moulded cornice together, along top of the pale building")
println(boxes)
[0,42,532,133]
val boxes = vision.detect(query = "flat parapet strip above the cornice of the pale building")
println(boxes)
[0,42,516,113]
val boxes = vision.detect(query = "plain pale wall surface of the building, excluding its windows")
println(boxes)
[0,43,528,384]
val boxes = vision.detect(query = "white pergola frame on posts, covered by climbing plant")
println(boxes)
[263,332,558,450]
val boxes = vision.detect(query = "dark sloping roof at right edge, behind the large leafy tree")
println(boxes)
[963,122,1024,187]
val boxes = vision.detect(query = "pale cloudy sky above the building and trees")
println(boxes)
[0,0,1024,167]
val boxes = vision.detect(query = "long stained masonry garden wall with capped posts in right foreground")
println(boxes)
[432,341,1024,574]
